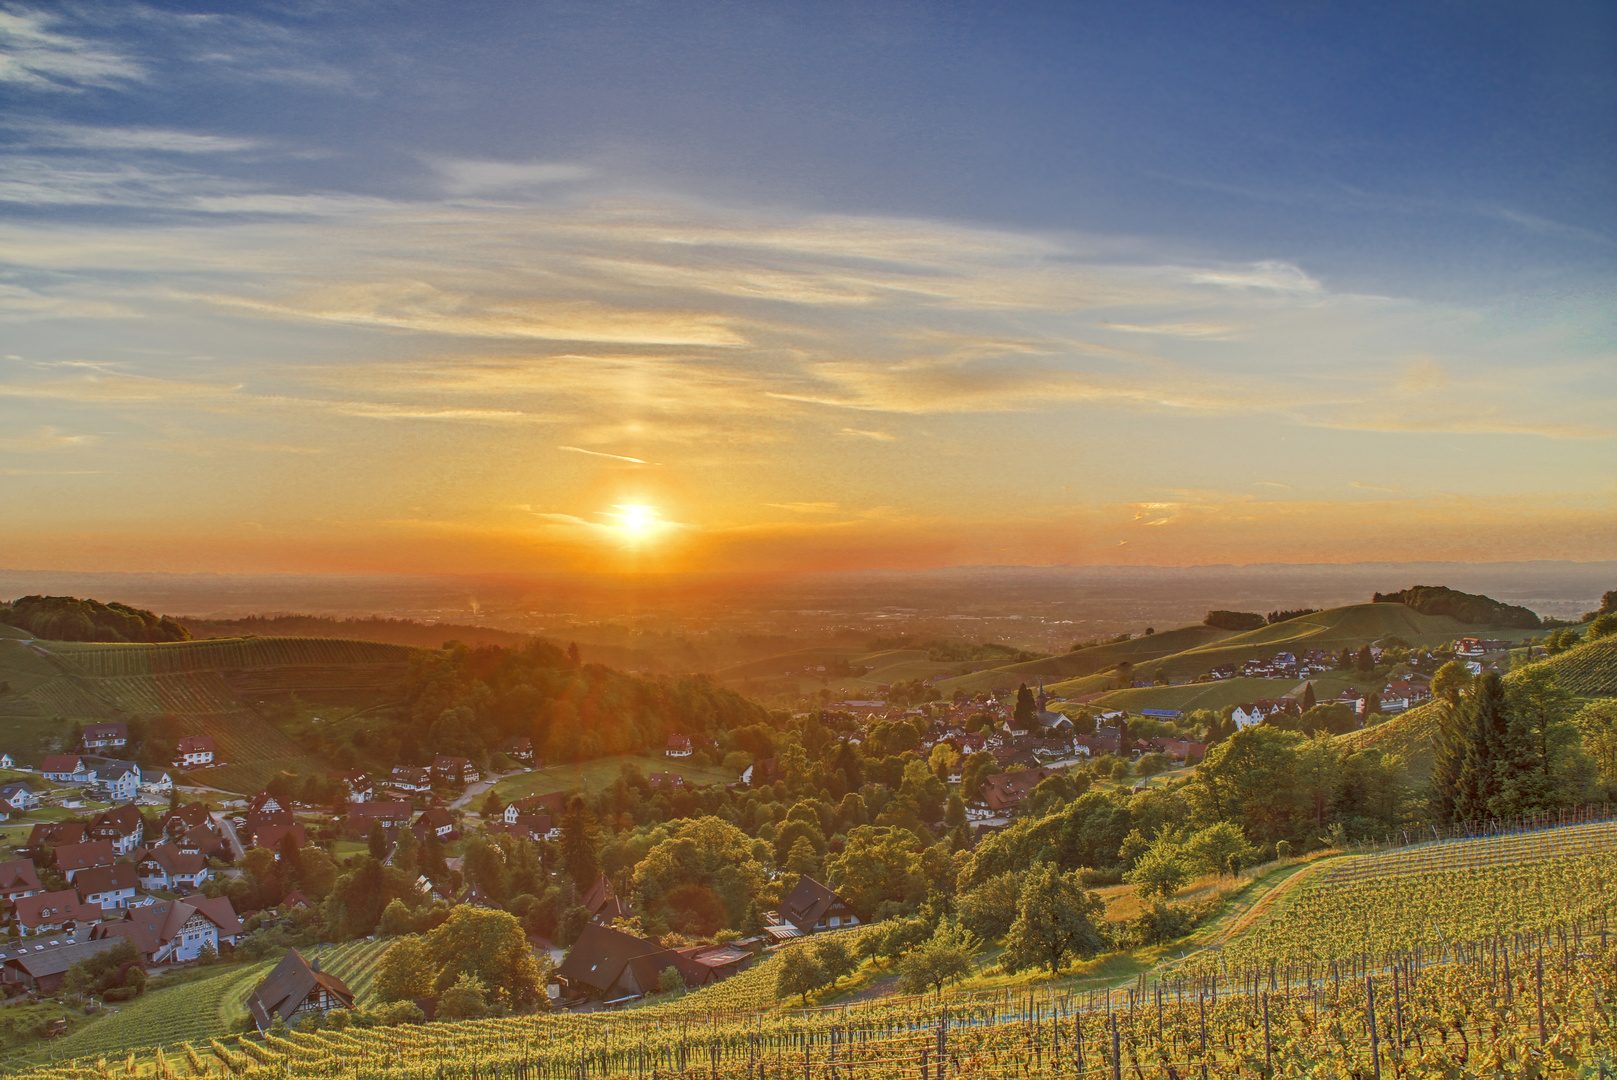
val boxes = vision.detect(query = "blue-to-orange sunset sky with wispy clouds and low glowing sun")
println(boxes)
[0,0,1617,572]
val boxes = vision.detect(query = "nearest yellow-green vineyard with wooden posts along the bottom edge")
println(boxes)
[18,925,1617,1080]
